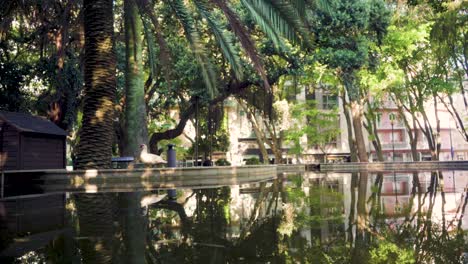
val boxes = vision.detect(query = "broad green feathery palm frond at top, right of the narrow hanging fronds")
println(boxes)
[242,0,312,47]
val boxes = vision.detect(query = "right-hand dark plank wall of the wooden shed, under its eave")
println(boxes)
[21,134,65,170]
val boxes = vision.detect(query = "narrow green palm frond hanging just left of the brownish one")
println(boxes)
[194,1,244,80]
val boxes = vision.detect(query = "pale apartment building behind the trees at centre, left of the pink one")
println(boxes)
[224,82,350,165]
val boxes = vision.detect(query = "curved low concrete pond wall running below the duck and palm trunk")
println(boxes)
[4,165,277,193]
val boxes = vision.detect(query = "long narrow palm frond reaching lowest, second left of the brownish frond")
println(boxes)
[168,0,217,98]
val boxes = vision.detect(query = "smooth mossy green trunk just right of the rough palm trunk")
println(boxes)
[123,0,148,157]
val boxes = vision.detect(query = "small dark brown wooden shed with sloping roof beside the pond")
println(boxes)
[0,111,67,171]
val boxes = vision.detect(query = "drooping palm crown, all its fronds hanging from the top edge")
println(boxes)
[137,0,322,151]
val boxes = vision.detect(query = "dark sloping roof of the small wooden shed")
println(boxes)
[0,111,67,136]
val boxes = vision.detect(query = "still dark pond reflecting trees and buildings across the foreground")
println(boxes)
[0,171,468,263]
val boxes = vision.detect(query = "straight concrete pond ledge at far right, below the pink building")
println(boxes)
[320,161,468,172]
